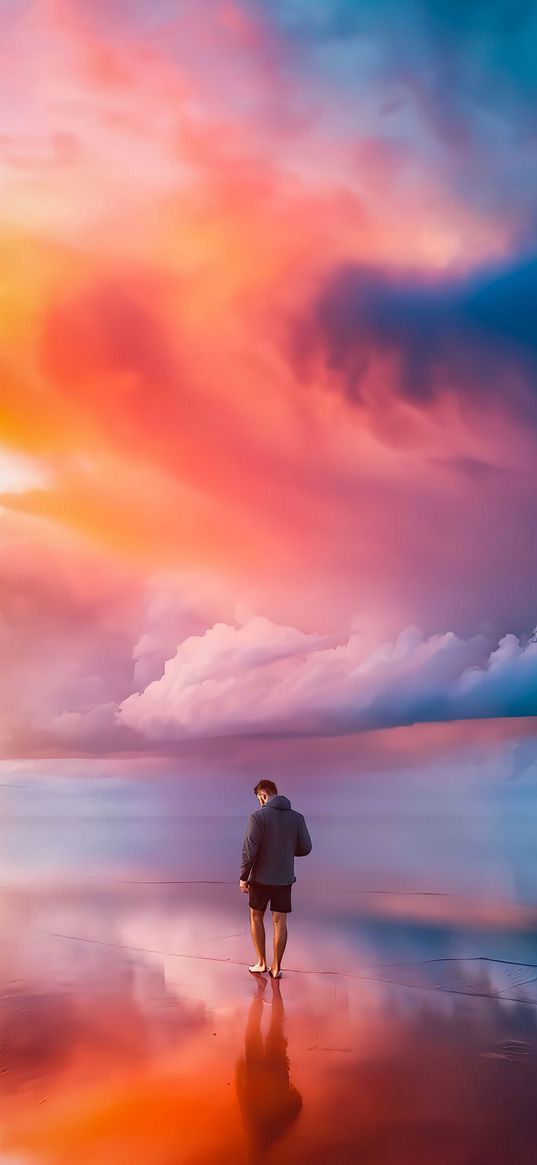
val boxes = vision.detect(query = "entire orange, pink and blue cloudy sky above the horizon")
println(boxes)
[0,0,537,769]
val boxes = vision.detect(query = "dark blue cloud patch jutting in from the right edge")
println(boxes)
[299,256,537,422]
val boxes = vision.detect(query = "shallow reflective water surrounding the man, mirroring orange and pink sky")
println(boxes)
[0,813,537,1165]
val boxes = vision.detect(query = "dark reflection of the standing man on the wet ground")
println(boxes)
[235,980,302,1162]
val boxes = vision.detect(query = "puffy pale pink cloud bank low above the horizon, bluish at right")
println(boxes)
[118,616,537,741]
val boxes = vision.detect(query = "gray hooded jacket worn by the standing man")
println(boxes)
[240,795,311,885]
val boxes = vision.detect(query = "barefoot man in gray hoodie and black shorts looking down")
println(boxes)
[239,781,311,979]
